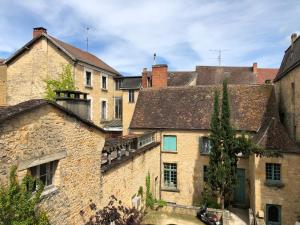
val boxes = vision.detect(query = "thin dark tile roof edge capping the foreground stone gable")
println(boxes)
[0,99,105,132]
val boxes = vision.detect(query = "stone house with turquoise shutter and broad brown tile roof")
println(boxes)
[129,84,300,224]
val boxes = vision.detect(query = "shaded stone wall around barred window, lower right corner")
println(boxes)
[253,153,300,225]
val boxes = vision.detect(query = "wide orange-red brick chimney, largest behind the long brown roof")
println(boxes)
[152,64,168,87]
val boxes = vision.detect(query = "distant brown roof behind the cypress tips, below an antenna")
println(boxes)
[196,66,255,85]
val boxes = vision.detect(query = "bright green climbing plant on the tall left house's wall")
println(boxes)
[44,64,75,101]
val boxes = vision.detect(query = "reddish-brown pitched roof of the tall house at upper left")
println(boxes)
[5,33,120,75]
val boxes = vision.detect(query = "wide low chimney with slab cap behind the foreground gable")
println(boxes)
[55,90,91,120]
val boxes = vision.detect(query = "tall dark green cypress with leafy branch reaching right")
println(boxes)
[208,80,280,209]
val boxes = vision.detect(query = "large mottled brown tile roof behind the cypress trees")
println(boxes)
[130,85,276,131]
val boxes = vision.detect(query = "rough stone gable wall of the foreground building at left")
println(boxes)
[0,105,104,225]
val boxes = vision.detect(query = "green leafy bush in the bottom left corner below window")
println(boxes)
[0,167,49,225]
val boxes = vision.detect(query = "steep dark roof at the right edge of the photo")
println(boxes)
[274,36,300,82]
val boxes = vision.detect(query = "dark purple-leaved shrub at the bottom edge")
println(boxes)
[80,195,144,225]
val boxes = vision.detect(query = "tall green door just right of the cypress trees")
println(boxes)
[234,168,246,206]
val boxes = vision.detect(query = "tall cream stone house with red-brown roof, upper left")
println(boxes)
[0,28,122,130]
